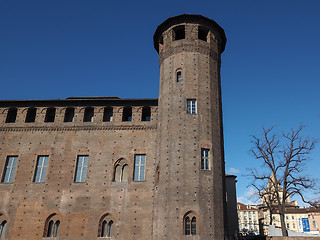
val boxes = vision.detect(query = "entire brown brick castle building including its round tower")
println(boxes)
[0,15,227,240]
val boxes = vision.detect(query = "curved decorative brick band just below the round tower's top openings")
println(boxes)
[159,44,219,63]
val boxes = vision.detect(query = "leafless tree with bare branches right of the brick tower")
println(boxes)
[249,125,318,236]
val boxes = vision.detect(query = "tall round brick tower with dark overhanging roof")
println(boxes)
[153,14,226,240]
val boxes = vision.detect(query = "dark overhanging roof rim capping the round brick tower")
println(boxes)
[153,14,227,53]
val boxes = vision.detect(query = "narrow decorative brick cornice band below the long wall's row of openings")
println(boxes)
[0,125,157,132]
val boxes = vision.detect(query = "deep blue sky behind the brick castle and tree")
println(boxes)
[0,0,320,203]
